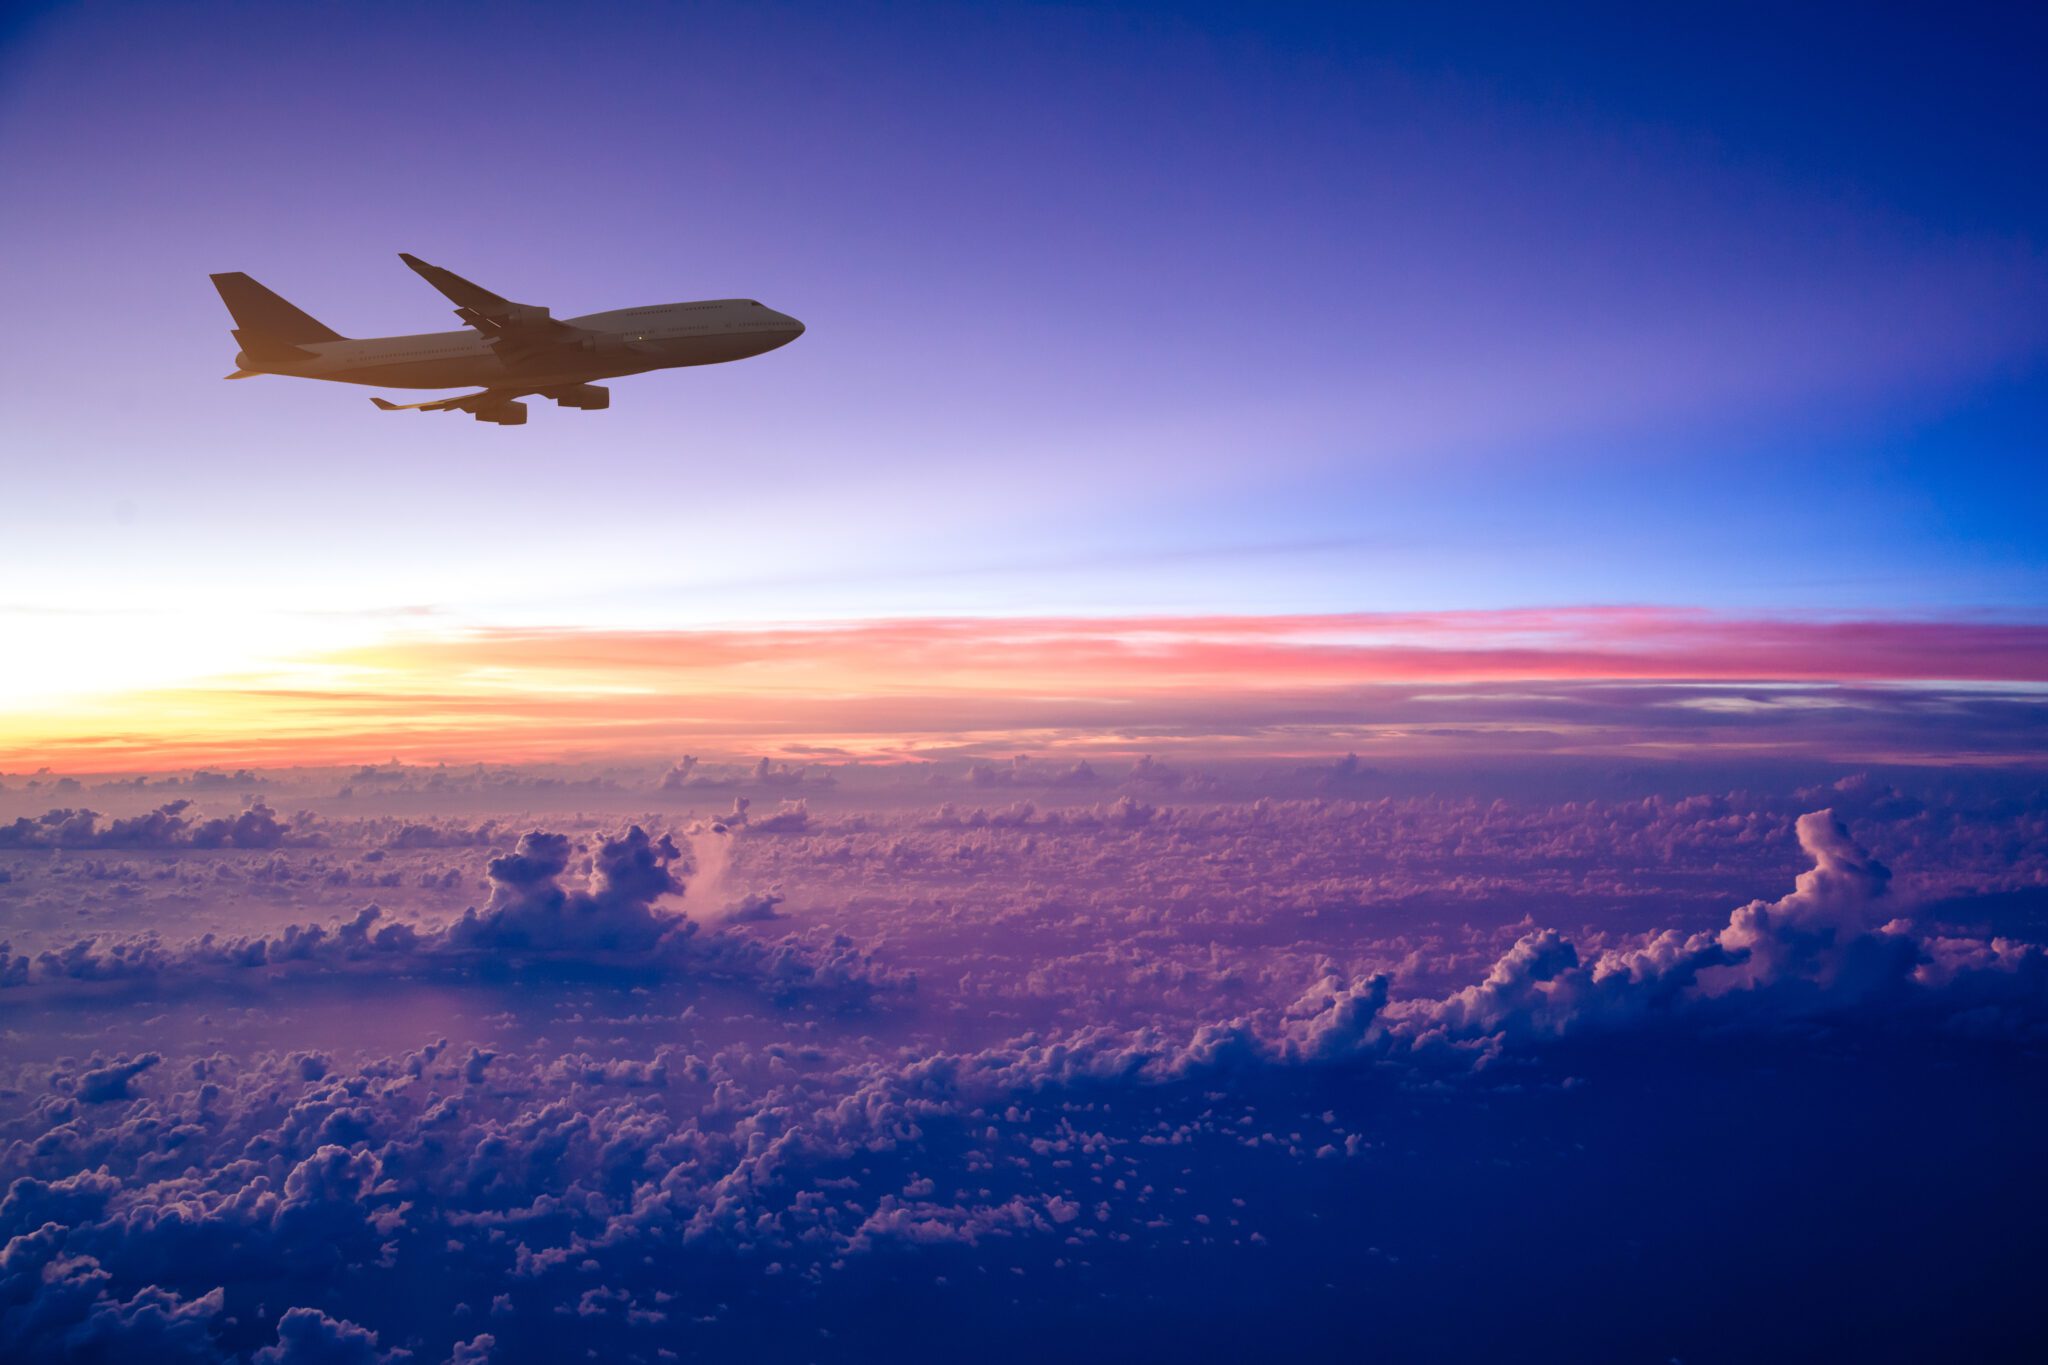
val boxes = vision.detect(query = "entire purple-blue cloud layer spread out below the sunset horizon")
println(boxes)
[0,773,2048,1361]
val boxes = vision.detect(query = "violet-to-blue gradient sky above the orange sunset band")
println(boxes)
[0,4,2048,765]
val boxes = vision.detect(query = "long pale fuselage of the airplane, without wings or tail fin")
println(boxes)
[236,299,803,389]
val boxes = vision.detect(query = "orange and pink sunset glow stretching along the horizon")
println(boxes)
[0,608,2048,772]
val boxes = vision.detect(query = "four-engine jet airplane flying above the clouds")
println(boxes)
[213,252,803,426]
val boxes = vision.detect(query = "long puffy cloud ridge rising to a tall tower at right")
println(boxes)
[876,810,2048,1095]
